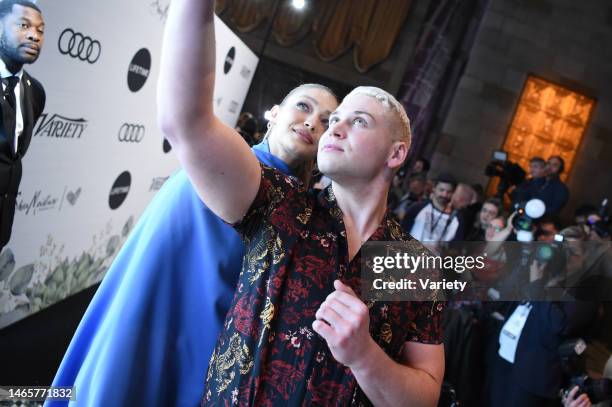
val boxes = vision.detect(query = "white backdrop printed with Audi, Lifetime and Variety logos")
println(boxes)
[0,0,258,328]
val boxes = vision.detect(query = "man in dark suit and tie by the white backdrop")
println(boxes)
[0,0,45,250]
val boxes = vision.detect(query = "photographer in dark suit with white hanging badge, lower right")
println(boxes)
[486,228,598,407]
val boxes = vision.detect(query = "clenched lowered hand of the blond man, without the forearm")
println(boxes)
[312,280,378,367]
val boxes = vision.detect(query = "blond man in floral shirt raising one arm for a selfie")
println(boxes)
[158,0,444,406]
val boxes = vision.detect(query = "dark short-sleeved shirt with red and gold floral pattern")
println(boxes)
[202,165,443,406]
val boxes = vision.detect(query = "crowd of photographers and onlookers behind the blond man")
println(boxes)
[389,156,612,407]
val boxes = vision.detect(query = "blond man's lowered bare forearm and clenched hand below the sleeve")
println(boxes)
[312,280,442,407]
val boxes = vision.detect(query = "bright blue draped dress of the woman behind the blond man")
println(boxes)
[45,142,289,407]
